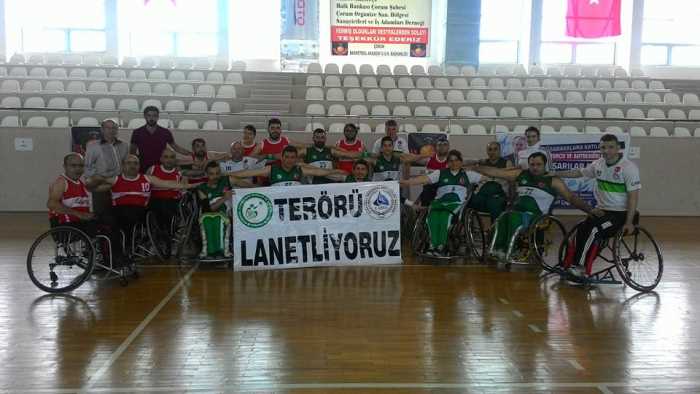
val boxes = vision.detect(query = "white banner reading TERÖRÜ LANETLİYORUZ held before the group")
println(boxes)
[233,182,401,271]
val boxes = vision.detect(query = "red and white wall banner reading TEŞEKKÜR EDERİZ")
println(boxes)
[331,0,432,57]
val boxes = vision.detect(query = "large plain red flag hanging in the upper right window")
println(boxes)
[566,0,622,38]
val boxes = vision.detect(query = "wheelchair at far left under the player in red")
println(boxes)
[27,226,138,293]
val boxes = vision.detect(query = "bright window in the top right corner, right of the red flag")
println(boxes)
[641,0,700,66]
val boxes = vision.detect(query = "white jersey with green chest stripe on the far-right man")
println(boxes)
[581,157,642,211]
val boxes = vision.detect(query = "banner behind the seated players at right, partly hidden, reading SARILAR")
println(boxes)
[496,133,630,209]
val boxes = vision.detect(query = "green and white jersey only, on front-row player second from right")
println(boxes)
[513,170,557,215]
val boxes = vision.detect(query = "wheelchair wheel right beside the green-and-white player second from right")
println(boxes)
[530,215,567,271]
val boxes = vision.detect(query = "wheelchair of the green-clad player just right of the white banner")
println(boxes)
[411,200,486,260]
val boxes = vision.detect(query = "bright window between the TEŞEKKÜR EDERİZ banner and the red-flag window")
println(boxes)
[479,0,530,63]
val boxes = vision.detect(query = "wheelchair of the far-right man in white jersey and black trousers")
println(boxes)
[542,213,664,293]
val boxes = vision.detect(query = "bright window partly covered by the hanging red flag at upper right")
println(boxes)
[540,0,619,64]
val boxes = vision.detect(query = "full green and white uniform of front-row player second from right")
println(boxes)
[494,170,557,252]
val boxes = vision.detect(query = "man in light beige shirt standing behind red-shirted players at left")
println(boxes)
[85,119,129,216]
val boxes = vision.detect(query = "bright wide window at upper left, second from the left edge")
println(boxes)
[118,0,219,57]
